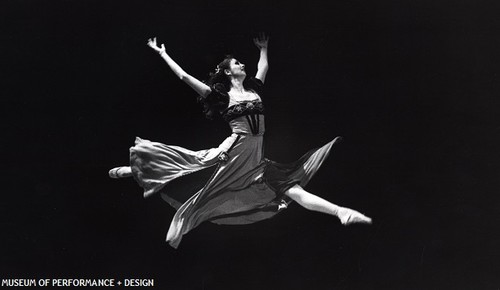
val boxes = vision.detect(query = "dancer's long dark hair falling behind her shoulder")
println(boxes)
[198,55,234,119]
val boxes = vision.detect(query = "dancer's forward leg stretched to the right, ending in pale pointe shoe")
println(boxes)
[285,185,372,225]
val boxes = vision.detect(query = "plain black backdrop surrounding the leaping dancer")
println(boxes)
[0,0,500,289]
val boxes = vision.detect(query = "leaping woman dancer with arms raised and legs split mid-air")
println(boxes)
[109,35,371,248]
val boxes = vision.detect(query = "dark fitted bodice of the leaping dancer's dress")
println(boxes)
[222,99,265,135]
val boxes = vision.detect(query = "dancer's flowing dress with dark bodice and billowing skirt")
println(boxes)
[130,79,337,248]
